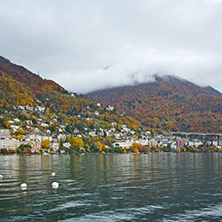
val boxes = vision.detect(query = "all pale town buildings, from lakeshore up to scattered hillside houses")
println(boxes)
[0,103,222,152]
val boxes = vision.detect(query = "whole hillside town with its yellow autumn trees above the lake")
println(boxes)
[0,103,222,154]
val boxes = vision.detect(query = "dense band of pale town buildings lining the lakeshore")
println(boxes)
[0,126,222,153]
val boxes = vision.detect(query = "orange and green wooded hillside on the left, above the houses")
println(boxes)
[0,57,141,132]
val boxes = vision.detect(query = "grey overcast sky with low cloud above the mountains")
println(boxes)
[0,0,222,93]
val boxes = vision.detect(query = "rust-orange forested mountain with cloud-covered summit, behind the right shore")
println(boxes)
[86,76,222,132]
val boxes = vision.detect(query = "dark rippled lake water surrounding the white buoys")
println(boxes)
[0,153,222,222]
